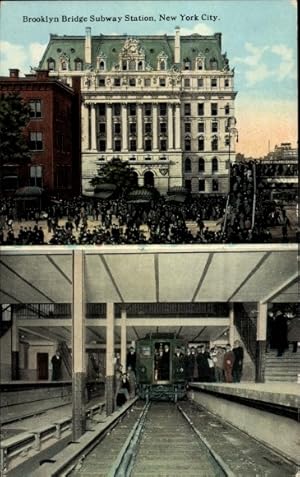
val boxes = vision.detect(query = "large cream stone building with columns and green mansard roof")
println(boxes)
[40,28,236,195]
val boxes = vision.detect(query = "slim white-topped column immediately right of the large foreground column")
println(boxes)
[105,303,115,416]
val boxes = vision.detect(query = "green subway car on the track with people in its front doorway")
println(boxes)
[136,333,186,402]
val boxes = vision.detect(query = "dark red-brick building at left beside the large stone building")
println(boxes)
[0,69,80,196]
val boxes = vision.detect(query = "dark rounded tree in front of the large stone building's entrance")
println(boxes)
[90,158,138,197]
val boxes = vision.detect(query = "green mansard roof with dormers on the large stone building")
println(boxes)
[39,33,227,70]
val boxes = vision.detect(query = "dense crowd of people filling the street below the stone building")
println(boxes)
[0,161,294,245]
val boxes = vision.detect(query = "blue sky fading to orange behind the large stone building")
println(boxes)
[0,0,298,157]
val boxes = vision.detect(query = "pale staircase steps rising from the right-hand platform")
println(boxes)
[265,347,300,383]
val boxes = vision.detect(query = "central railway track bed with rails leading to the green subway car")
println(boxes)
[67,401,297,477]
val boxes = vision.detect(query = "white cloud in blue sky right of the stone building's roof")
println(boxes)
[232,42,297,87]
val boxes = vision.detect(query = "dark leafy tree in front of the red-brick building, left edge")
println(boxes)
[0,93,30,190]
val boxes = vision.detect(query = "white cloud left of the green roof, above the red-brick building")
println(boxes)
[0,41,46,76]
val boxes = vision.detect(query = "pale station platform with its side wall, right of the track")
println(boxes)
[188,382,300,466]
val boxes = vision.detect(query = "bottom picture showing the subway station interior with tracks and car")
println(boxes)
[0,243,300,477]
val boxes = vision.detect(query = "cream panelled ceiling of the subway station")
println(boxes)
[0,244,299,346]
